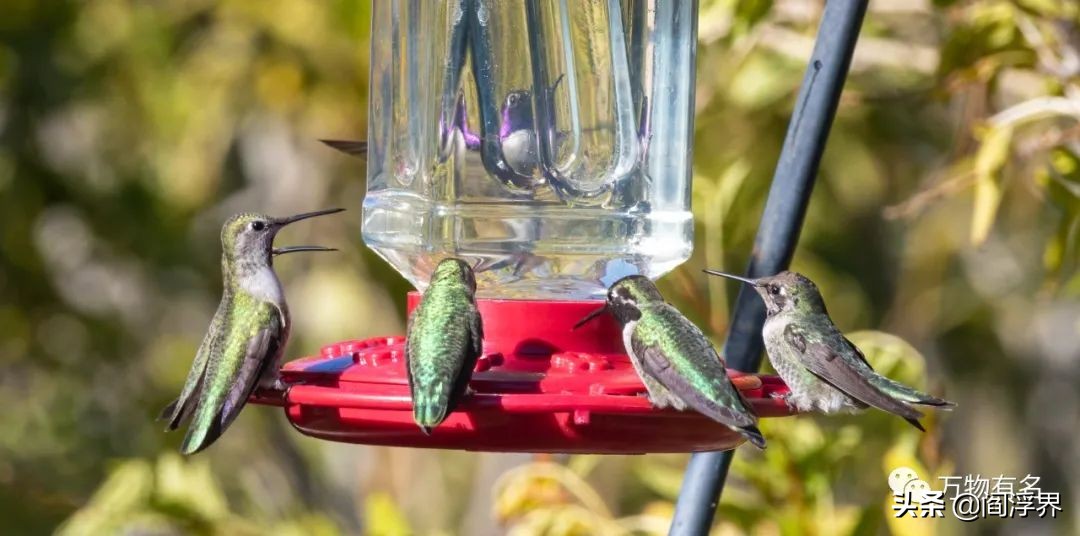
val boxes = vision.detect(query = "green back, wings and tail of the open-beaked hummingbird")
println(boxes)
[180,294,286,454]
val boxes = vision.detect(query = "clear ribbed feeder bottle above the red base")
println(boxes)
[363,0,698,299]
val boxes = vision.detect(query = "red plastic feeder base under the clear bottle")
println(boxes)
[253,293,792,454]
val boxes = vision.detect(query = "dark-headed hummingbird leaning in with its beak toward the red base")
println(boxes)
[575,276,765,448]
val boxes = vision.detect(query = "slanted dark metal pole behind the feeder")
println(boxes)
[670,0,867,536]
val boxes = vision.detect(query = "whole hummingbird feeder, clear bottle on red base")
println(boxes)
[255,0,789,453]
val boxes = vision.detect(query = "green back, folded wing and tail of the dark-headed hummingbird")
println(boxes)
[629,304,765,448]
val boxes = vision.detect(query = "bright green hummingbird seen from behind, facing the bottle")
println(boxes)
[405,257,484,433]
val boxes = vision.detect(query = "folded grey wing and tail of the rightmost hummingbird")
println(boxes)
[784,322,926,431]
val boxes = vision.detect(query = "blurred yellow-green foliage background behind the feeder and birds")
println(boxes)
[0,0,1080,535]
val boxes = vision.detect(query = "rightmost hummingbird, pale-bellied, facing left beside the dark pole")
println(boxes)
[705,270,956,431]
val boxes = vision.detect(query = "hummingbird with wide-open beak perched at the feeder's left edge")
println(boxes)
[159,209,345,454]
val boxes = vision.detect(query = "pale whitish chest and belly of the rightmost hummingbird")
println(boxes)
[761,316,856,413]
